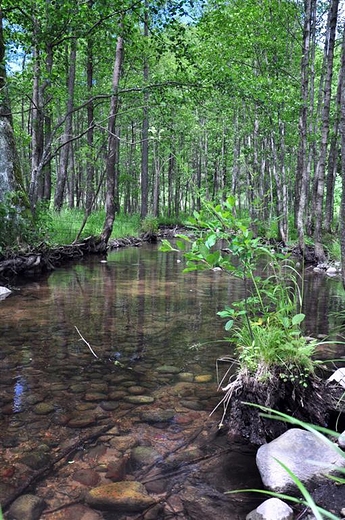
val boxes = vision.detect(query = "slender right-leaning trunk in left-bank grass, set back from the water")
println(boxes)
[54,39,77,211]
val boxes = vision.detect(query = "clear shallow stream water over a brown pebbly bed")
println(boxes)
[0,245,344,520]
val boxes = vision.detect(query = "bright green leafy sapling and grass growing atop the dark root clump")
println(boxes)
[161,197,316,385]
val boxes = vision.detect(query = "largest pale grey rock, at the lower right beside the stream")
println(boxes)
[256,428,345,493]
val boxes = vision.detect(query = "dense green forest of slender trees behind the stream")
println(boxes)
[0,0,345,262]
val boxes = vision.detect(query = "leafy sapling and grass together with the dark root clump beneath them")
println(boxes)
[161,197,323,442]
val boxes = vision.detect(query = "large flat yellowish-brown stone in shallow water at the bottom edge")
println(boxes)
[85,481,156,512]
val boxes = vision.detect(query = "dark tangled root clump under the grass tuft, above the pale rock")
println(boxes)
[215,367,334,446]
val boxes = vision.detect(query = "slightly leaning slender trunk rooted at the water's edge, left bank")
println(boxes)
[101,36,123,249]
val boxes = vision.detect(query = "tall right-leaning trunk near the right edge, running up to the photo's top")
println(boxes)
[314,0,339,262]
